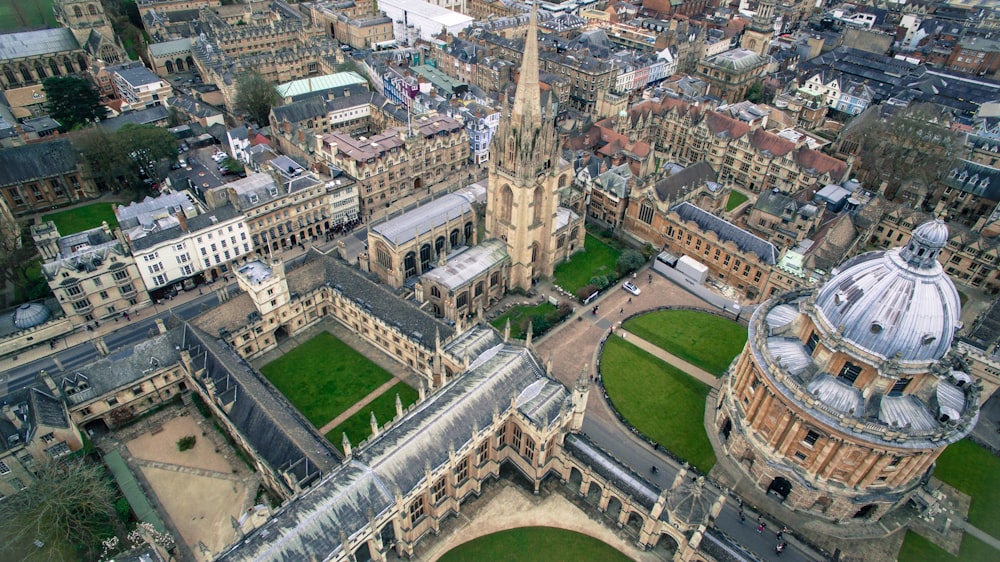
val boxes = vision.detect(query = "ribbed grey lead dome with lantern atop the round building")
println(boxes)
[816,219,961,364]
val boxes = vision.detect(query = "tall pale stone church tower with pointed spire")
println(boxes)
[486,7,571,289]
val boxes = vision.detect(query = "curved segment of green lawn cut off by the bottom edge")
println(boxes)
[438,527,629,562]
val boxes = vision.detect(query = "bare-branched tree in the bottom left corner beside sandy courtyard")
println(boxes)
[0,458,116,559]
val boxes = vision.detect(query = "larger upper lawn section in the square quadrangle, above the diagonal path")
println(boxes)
[261,332,392,427]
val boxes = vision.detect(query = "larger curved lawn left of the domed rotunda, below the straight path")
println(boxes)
[601,336,715,472]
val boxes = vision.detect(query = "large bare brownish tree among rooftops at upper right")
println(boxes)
[841,103,965,203]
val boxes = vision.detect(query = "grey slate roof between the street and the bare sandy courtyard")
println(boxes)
[62,329,184,406]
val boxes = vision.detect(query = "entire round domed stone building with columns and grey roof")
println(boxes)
[715,220,979,523]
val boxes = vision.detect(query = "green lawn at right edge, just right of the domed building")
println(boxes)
[934,440,1000,532]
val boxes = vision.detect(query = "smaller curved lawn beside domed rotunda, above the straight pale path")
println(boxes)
[625,310,747,377]
